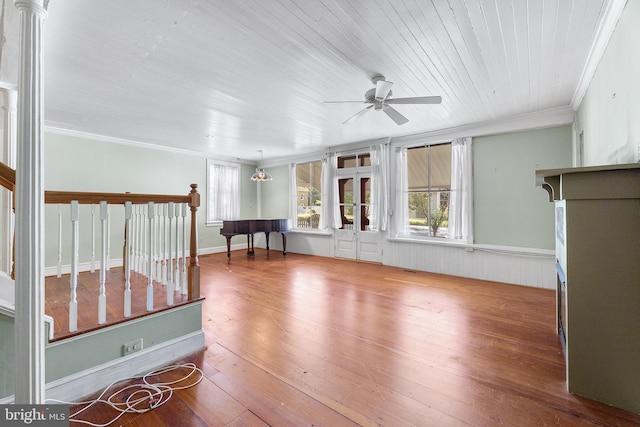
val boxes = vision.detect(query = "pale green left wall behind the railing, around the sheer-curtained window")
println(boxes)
[44,132,257,267]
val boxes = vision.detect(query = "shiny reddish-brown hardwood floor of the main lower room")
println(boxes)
[65,250,640,427]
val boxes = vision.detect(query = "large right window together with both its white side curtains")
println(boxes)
[394,138,473,243]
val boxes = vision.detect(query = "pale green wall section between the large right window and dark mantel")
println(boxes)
[473,126,572,249]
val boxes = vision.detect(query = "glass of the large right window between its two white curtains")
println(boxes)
[407,143,451,237]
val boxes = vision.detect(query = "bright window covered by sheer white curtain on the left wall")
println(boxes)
[207,160,240,224]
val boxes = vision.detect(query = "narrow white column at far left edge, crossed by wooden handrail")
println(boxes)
[0,87,18,274]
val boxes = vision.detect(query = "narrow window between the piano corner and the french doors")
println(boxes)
[295,161,322,229]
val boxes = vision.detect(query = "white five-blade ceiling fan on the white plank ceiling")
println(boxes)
[323,75,442,125]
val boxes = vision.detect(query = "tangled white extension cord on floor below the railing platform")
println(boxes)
[47,363,204,427]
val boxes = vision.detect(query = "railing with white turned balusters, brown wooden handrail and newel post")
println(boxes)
[0,162,200,332]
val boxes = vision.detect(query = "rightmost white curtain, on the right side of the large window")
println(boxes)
[447,137,473,243]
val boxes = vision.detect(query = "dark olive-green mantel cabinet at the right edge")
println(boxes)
[536,164,640,413]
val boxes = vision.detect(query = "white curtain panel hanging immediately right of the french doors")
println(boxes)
[369,144,389,231]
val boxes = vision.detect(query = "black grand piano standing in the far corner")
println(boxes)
[220,219,291,258]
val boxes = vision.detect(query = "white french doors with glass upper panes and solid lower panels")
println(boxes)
[335,172,382,262]
